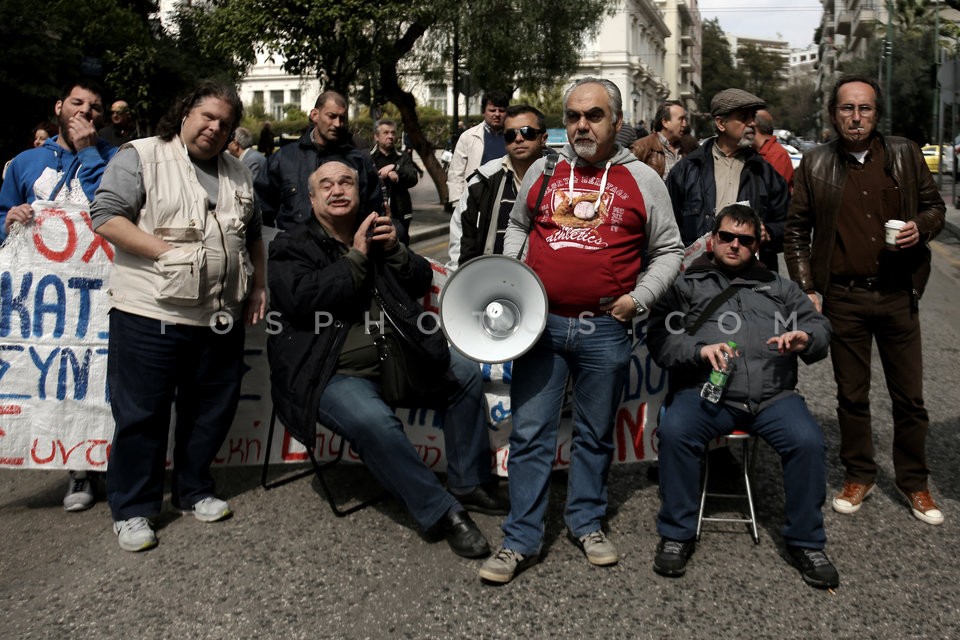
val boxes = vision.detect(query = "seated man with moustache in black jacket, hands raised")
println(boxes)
[267,161,509,558]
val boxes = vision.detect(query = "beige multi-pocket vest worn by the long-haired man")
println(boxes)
[108,138,254,326]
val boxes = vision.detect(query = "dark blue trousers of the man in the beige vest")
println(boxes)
[107,309,244,520]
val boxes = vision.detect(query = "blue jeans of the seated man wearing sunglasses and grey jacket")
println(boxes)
[657,389,827,549]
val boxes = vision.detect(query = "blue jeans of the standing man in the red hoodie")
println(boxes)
[503,314,631,555]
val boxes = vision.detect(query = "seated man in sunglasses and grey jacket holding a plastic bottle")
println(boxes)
[647,204,840,588]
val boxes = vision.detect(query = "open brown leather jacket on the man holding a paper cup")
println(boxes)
[783,134,946,295]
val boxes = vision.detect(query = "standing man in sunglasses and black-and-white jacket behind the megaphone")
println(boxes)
[448,104,547,268]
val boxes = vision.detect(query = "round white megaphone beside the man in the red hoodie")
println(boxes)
[440,255,547,363]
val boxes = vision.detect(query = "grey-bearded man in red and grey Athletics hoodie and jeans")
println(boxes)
[480,78,683,583]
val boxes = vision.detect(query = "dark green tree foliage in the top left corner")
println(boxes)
[0,0,240,165]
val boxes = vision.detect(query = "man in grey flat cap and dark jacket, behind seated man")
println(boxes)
[667,89,790,271]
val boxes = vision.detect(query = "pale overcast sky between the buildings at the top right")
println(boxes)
[697,0,823,49]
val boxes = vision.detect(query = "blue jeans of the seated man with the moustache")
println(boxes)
[318,351,493,530]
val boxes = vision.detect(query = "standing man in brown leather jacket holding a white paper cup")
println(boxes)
[784,76,945,525]
